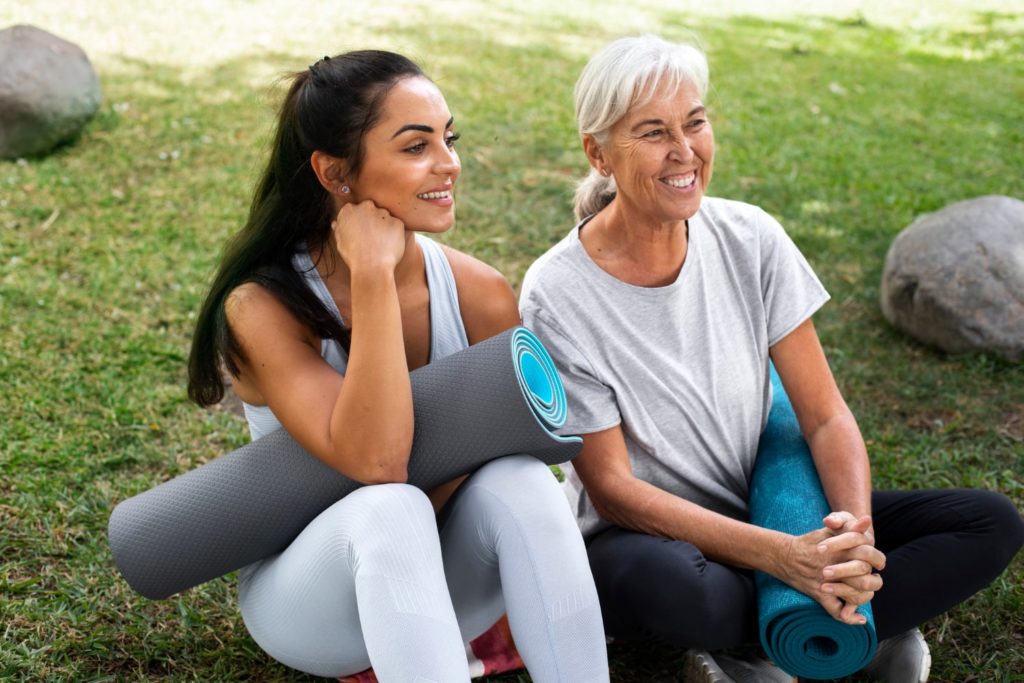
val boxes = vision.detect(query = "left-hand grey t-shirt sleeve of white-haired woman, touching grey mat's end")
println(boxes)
[522,307,622,434]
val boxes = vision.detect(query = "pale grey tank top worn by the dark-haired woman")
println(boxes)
[242,233,469,439]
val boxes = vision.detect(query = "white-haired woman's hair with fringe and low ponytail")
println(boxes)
[572,35,708,220]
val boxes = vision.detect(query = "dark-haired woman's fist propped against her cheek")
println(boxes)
[331,200,406,272]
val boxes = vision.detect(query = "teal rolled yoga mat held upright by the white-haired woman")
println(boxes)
[750,367,878,679]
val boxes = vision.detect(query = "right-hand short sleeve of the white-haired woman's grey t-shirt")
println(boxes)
[759,211,829,347]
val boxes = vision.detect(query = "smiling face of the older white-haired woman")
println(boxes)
[591,76,715,223]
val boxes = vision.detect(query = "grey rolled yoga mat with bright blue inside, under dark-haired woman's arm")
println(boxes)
[108,328,582,599]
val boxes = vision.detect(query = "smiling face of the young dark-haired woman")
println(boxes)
[345,77,462,232]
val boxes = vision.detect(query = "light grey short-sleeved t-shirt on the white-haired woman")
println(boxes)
[519,198,828,537]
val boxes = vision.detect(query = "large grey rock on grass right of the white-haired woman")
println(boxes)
[882,196,1024,360]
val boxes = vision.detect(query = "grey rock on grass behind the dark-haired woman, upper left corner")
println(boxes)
[0,26,100,159]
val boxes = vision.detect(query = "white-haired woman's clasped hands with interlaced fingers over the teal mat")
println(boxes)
[779,512,886,625]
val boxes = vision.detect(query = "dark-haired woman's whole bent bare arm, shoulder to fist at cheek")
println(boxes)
[225,202,413,483]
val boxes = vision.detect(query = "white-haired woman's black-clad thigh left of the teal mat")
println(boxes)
[587,527,757,649]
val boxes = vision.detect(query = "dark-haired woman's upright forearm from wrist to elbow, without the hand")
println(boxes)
[330,270,413,483]
